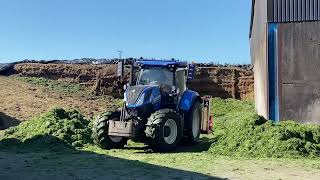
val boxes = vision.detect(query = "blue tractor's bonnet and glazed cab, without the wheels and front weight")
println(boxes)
[124,61,187,118]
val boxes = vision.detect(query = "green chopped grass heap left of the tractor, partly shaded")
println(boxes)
[0,108,92,150]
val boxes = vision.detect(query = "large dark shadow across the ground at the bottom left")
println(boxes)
[0,135,222,180]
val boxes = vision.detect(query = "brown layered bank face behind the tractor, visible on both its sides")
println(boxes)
[12,63,254,100]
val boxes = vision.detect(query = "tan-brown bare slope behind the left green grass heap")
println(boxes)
[0,76,116,127]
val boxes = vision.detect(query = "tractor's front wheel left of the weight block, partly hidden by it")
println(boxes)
[92,112,128,149]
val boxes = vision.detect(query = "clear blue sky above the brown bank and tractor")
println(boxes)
[0,0,251,63]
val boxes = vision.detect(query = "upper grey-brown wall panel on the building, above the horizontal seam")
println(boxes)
[278,22,320,83]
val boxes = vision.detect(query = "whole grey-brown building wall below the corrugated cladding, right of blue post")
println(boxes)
[278,21,320,124]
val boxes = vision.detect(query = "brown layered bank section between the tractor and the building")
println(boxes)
[190,66,254,100]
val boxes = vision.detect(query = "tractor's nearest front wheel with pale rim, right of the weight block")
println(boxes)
[145,109,183,151]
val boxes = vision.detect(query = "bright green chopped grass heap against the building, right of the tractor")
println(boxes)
[209,98,320,158]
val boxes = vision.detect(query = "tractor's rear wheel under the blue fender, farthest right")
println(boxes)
[185,101,202,144]
